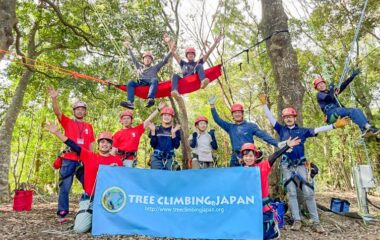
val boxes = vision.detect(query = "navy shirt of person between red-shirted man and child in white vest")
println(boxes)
[149,126,181,152]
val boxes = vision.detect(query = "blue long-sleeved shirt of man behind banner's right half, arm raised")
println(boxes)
[211,108,278,152]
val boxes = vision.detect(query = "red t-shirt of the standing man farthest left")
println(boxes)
[59,113,95,161]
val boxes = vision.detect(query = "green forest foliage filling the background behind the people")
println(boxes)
[0,0,380,191]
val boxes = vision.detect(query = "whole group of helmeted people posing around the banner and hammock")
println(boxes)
[46,35,379,239]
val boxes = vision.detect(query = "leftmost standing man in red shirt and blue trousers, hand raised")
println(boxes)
[48,87,95,223]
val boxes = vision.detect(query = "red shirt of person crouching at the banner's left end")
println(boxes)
[80,148,123,196]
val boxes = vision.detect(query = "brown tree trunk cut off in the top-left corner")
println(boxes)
[0,0,17,60]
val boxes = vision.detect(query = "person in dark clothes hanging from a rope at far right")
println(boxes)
[313,69,380,138]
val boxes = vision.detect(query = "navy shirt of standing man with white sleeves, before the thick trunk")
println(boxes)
[274,122,317,160]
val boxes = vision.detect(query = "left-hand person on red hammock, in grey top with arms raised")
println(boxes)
[120,35,174,109]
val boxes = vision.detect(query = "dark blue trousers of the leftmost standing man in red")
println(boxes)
[57,159,84,217]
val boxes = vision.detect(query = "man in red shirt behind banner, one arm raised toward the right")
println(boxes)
[112,102,166,167]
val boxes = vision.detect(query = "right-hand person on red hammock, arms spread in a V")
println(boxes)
[164,34,222,97]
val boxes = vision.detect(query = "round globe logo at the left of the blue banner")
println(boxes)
[101,187,127,213]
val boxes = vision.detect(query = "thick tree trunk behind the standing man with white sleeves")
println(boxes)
[259,0,305,195]
